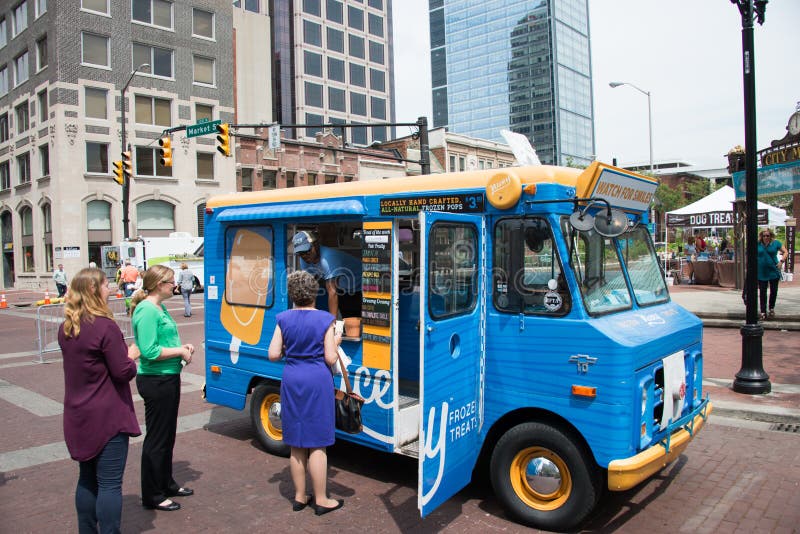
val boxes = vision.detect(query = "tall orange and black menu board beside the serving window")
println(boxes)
[361,221,392,370]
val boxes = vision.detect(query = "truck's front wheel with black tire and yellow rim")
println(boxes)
[489,423,602,530]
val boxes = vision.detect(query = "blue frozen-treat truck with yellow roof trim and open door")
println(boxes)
[205,162,711,529]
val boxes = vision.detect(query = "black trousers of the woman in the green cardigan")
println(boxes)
[136,375,181,506]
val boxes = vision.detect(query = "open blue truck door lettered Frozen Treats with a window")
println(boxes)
[418,211,486,517]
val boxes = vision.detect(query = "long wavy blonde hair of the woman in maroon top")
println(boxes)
[64,267,114,337]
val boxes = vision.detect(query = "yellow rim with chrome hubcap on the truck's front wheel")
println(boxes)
[509,447,572,511]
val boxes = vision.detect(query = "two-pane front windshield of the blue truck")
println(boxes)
[564,219,669,315]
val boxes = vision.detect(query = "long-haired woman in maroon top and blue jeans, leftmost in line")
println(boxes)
[58,268,141,533]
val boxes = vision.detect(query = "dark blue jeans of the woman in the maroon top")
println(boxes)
[75,434,129,534]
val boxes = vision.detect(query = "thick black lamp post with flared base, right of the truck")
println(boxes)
[731,0,772,394]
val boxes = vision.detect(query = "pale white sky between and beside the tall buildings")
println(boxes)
[392,0,800,168]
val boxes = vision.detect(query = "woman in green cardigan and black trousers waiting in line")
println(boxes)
[131,265,194,512]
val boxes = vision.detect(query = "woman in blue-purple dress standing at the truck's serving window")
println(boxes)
[269,271,344,515]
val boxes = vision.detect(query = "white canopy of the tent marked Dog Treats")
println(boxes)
[667,185,786,227]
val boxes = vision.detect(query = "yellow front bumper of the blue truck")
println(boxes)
[608,399,713,491]
